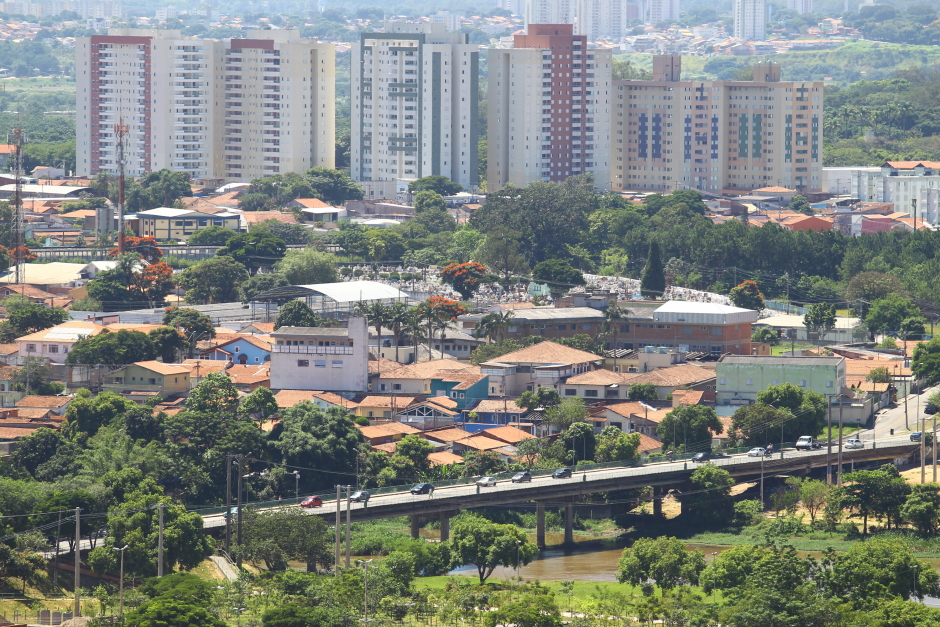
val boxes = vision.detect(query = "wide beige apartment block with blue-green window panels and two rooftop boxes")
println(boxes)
[611,55,823,193]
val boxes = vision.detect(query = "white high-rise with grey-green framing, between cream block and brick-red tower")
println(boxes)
[350,22,480,189]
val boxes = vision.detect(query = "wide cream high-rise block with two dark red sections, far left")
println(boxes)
[75,29,335,181]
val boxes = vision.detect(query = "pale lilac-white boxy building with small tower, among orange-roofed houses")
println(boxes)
[271,316,369,392]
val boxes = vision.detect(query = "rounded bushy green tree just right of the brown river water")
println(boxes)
[617,536,705,590]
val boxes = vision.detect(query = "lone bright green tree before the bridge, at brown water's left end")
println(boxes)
[450,514,539,584]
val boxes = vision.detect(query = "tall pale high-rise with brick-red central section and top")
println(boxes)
[486,24,611,190]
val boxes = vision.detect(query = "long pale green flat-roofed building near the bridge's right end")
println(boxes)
[716,355,846,405]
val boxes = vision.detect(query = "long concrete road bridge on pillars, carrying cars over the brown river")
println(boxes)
[203,436,920,547]
